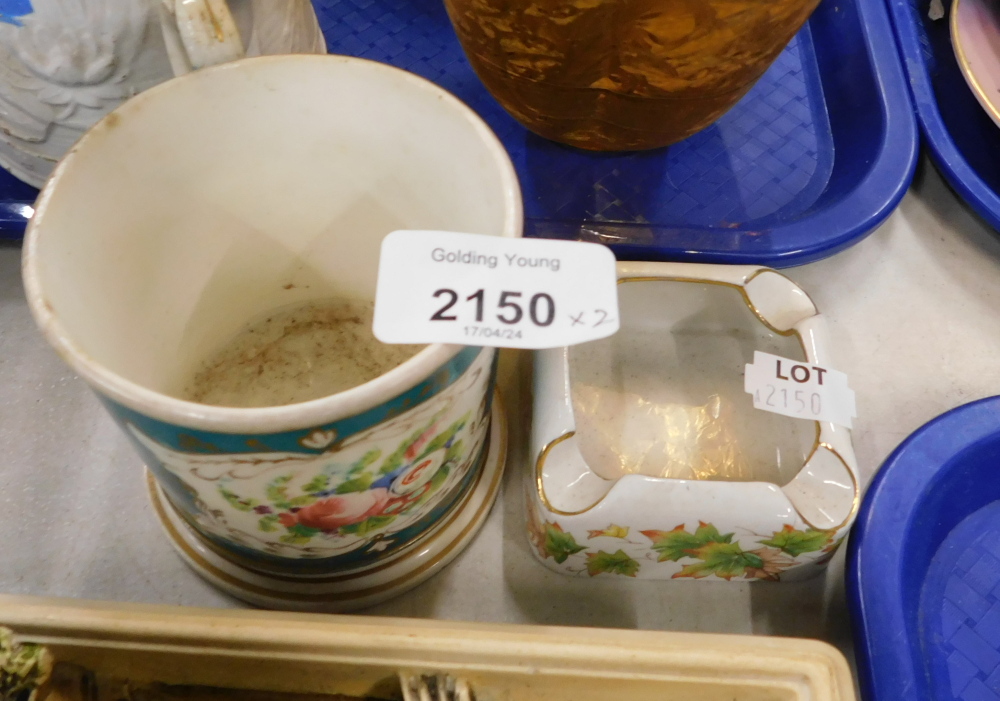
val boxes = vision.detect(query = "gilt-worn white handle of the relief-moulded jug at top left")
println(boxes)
[160,0,246,75]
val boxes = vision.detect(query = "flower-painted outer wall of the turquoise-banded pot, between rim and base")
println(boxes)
[102,347,496,573]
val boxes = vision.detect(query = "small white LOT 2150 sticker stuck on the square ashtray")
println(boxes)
[743,351,858,428]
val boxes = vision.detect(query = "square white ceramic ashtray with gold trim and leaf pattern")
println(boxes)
[528,262,860,581]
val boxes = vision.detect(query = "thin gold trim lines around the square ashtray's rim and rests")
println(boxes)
[535,268,836,530]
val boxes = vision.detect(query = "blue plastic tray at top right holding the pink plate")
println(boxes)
[889,0,1000,229]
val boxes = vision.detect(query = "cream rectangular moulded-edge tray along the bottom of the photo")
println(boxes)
[0,597,854,701]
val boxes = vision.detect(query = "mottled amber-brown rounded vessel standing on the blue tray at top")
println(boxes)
[445,0,819,151]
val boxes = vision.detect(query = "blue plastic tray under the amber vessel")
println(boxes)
[0,0,917,266]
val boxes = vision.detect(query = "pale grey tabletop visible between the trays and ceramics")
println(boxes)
[0,156,1000,668]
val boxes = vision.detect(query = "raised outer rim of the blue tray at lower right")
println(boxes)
[846,397,1000,701]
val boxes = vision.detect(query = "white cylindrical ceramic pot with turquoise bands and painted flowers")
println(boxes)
[24,55,522,610]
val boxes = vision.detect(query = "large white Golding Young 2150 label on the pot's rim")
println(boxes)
[373,231,618,348]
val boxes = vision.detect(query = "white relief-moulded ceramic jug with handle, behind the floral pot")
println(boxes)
[0,0,326,187]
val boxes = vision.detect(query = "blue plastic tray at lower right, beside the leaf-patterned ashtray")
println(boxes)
[847,397,1000,701]
